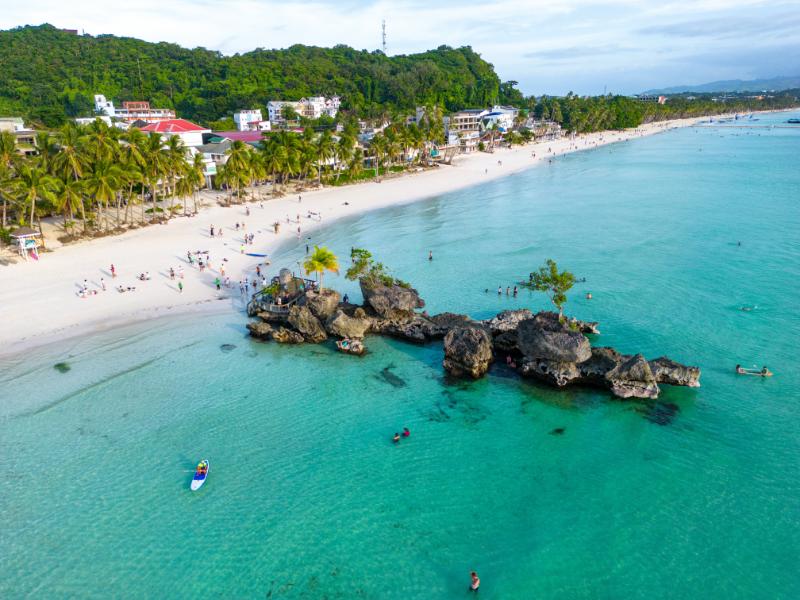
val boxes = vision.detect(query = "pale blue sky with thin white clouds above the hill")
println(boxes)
[0,0,800,95]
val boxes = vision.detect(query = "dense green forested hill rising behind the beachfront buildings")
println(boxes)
[0,25,522,126]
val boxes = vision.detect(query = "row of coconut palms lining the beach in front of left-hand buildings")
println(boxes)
[0,107,454,236]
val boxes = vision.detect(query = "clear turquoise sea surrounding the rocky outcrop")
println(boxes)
[0,113,800,600]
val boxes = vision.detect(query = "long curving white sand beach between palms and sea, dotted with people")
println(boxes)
[0,119,700,355]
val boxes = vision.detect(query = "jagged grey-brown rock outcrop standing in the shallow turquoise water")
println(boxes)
[247,280,700,398]
